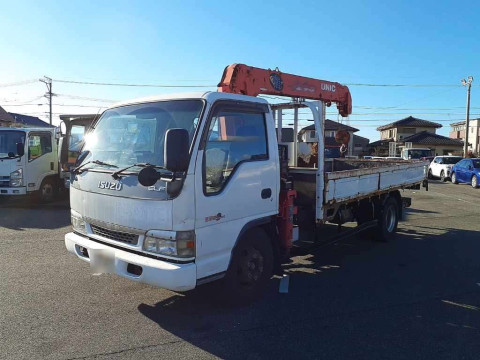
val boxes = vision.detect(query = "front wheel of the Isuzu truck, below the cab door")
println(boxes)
[224,228,274,304]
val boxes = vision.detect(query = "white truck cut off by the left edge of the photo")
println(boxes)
[0,128,59,202]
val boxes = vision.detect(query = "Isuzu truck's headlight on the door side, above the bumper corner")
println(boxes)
[143,230,195,258]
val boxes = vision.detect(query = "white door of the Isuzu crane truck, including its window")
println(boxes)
[195,101,279,279]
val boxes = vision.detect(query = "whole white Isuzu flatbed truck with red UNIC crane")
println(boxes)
[65,64,426,300]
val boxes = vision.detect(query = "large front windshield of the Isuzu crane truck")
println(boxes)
[83,100,203,167]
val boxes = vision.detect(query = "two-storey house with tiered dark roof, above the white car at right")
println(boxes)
[370,116,463,156]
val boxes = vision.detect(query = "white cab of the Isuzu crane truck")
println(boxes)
[65,92,279,291]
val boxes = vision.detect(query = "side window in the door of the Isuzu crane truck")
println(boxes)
[204,110,268,194]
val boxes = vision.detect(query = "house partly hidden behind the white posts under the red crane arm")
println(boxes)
[298,119,360,155]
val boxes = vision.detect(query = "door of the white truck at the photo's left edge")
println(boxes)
[25,131,58,191]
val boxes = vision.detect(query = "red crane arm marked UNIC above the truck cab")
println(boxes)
[218,64,352,116]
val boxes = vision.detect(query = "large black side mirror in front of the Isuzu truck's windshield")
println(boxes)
[163,129,190,172]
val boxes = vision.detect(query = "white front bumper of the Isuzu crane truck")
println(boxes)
[65,233,197,291]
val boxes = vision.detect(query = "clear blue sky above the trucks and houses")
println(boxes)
[0,0,480,141]
